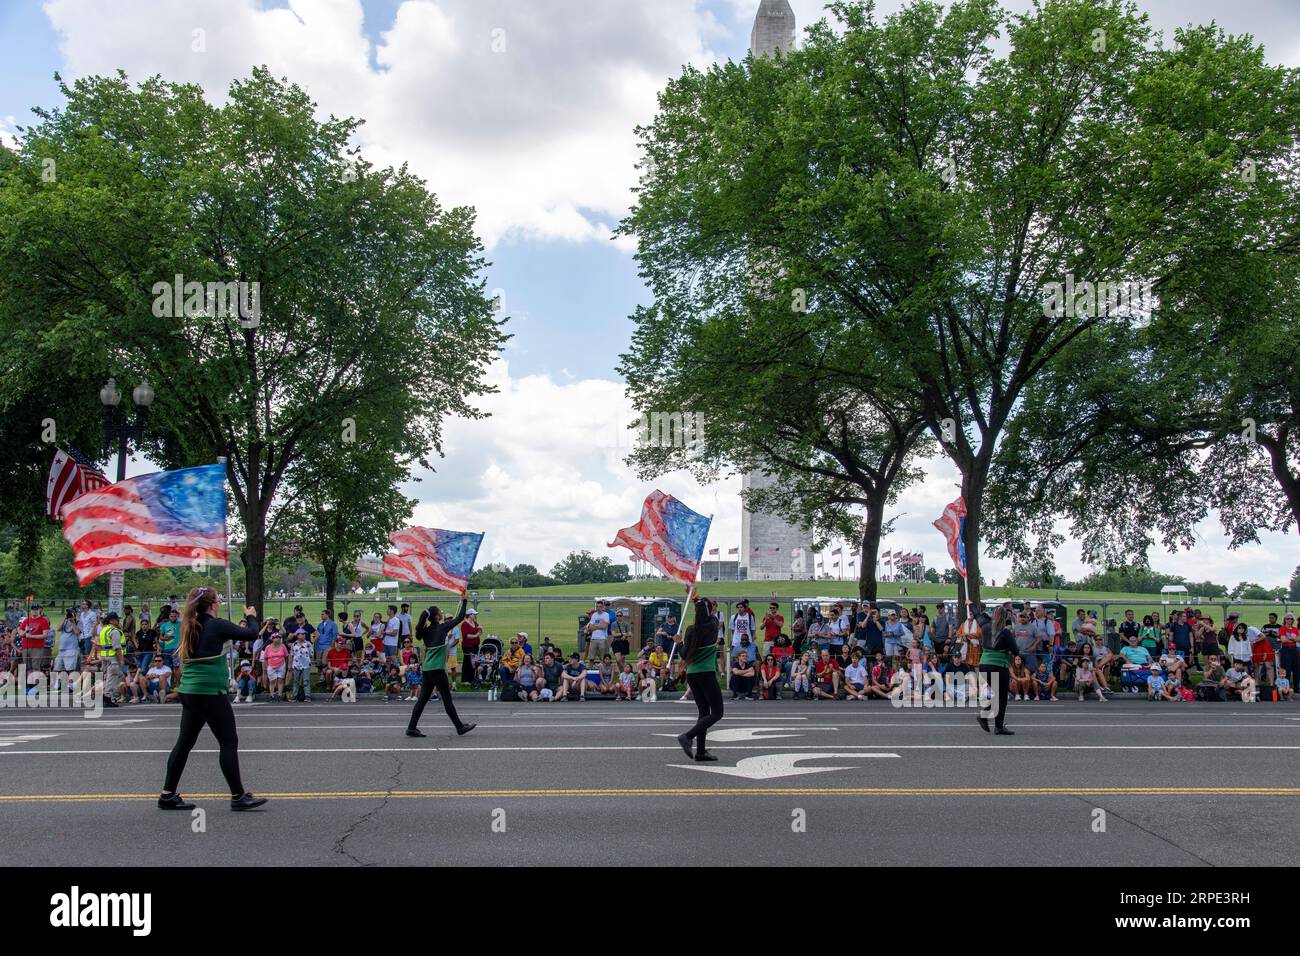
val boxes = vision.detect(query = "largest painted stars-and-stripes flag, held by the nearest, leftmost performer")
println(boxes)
[62,464,230,587]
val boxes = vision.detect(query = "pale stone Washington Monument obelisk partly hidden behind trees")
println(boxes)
[740,0,815,581]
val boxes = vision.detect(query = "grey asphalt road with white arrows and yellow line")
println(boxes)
[0,698,1300,866]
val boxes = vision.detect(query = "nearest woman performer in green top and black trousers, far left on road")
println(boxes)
[158,588,267,810]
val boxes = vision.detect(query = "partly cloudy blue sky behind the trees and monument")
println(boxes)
[0,0,1300,585]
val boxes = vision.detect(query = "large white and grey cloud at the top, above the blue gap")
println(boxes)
[44,0,719,248]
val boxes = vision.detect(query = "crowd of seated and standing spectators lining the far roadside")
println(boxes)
[0,600,1300,704]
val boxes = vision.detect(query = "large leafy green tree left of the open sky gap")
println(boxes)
[0,69,503,604]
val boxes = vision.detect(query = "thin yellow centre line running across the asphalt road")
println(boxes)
[0,787,1300,804]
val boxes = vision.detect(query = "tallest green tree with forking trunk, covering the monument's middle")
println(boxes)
[618,0,1291,600]
